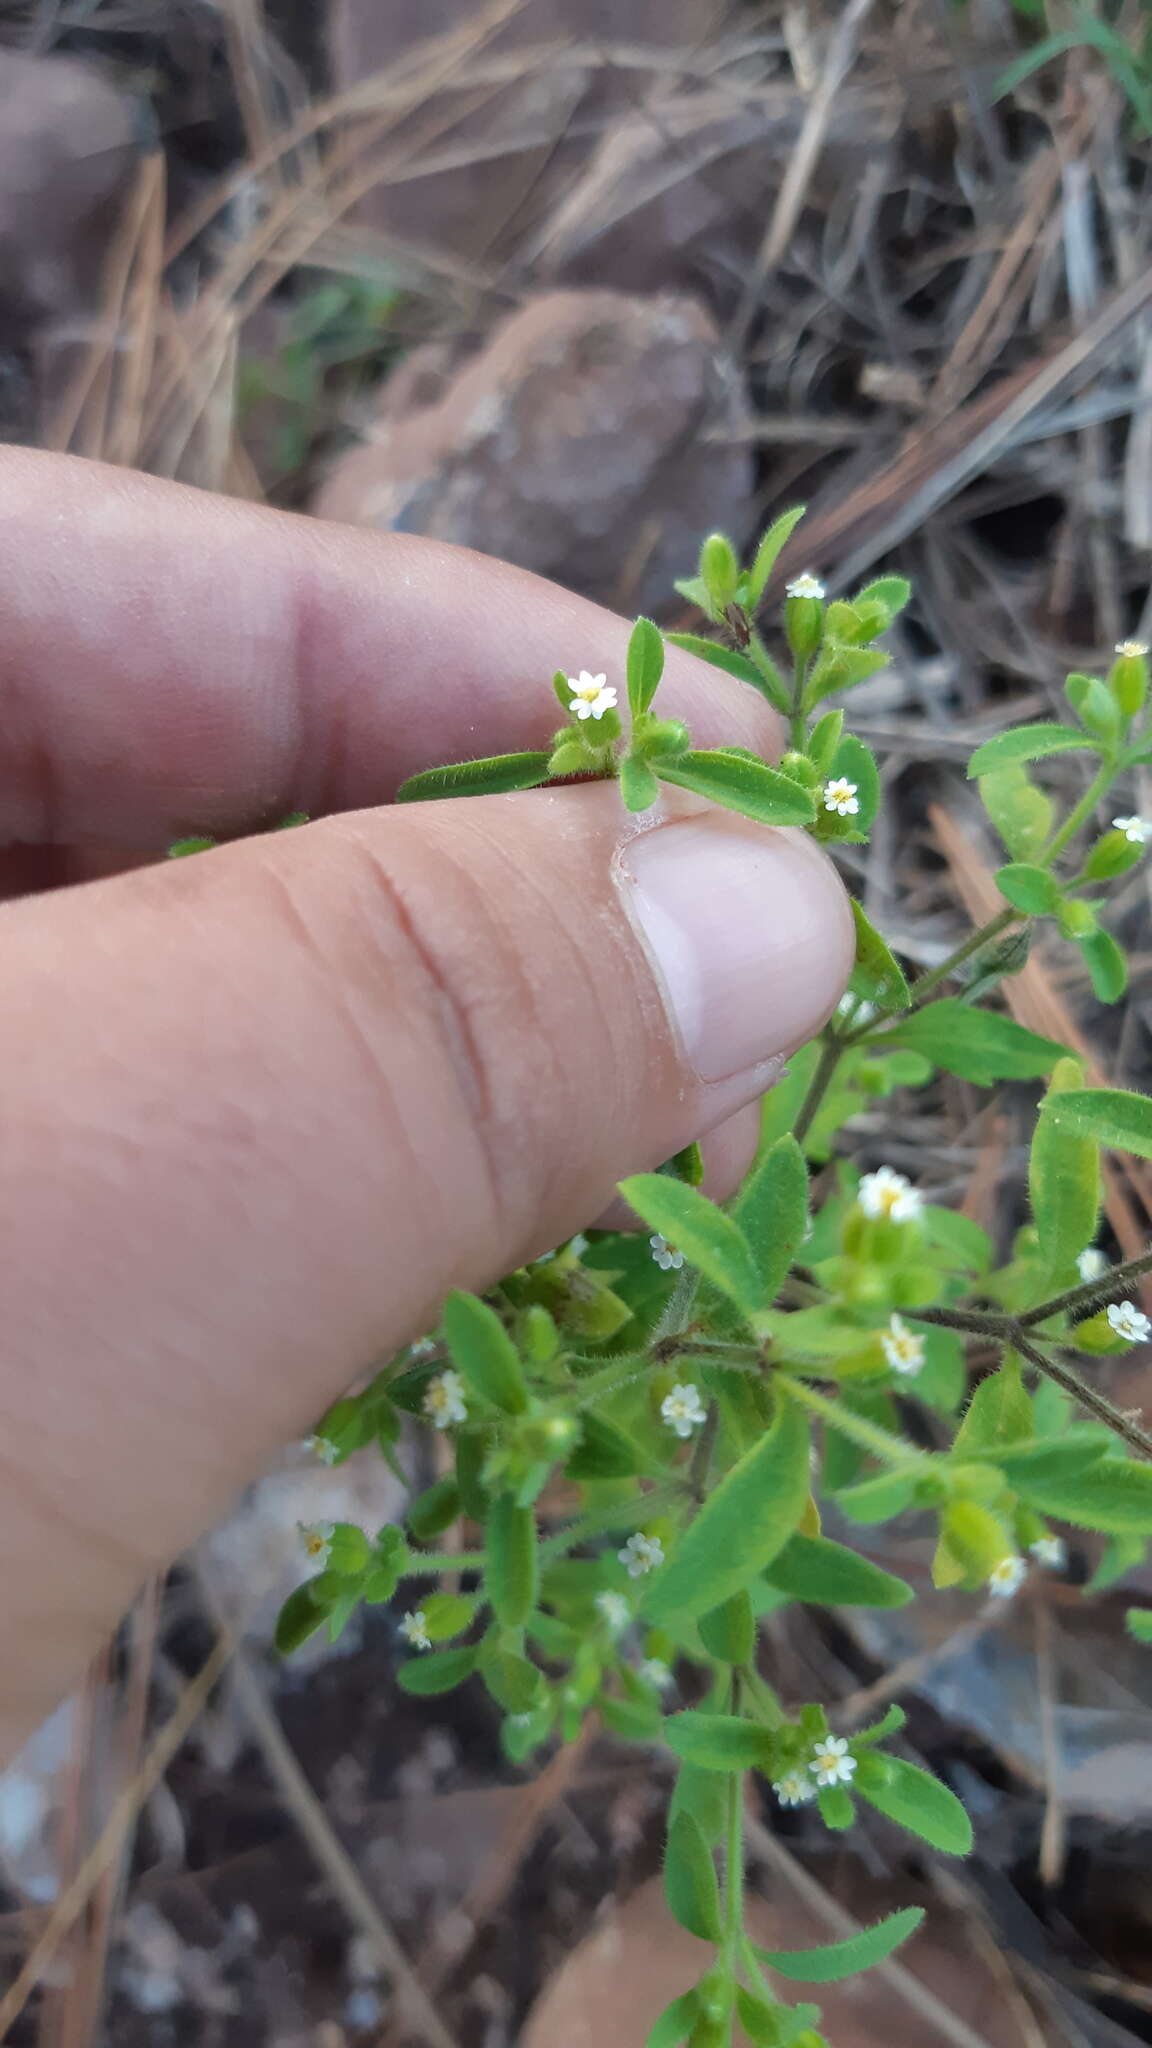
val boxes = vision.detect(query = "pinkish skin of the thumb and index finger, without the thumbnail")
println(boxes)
[0,451,851,1753]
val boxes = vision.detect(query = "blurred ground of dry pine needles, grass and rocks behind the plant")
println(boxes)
[0,0,1152,2048]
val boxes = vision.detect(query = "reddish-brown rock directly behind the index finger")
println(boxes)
[314,291,752,610]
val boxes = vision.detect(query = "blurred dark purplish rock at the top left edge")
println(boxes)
[0,49,137,342]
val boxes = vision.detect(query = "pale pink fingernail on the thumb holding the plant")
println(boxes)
[617,811,855,1081]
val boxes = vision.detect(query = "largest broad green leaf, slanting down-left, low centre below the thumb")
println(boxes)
[646,1403,810,1620]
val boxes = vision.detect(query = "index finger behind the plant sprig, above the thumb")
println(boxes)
[0,449,781,848]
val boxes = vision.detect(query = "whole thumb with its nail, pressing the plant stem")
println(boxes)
[0,786,853,1744]
